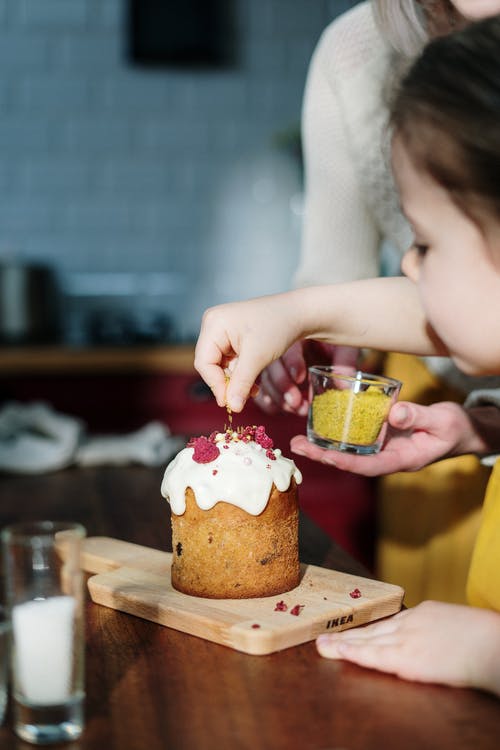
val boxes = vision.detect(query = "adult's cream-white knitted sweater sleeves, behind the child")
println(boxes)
[294,2,500,396]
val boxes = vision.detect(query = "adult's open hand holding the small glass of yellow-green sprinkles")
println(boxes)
[291,401,484,476]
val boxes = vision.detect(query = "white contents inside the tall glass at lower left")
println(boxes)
[12,596,76,706]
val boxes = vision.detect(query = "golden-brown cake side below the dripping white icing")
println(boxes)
[172,478,300,599]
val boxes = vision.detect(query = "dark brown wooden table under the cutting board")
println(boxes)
[0,468,500,750]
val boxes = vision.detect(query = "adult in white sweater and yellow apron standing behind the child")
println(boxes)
[256,0,500,605]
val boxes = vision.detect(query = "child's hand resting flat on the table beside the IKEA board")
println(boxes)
[316,601,500,696]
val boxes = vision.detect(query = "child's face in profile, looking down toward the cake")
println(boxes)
[392,137,500,375]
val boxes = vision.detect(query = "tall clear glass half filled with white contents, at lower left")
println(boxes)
[2,521,85,745]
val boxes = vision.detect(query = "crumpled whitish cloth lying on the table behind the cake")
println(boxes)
[0,402,185,474]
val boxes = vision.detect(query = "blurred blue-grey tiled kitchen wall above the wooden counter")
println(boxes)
[0,0,355,345]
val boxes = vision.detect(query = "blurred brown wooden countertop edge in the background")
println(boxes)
[0,344,194,377]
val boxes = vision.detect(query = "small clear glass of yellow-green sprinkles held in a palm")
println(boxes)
[307,365,402,454]
